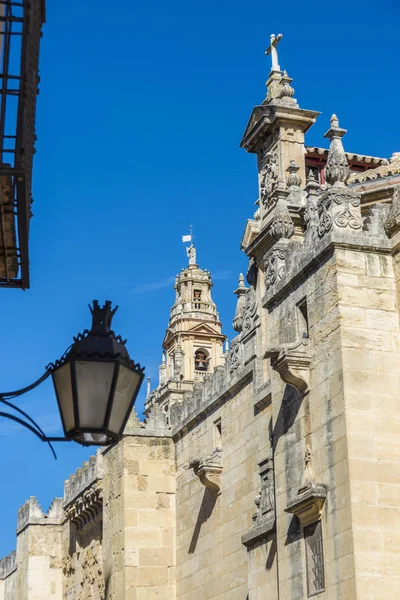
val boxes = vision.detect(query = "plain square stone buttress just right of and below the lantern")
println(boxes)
[103,429,176,600]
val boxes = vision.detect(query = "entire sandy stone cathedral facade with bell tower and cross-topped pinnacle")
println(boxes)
[0,36,400,600]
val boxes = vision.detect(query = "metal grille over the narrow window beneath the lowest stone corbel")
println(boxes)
[304,521,325,597]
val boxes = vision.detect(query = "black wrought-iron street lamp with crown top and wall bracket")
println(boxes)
[0,300,144,452]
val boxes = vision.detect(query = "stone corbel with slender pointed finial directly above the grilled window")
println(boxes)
[285,446,326,527]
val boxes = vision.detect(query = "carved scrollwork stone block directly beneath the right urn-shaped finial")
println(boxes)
[318,187,363,237]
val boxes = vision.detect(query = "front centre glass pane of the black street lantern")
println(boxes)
[75,361,115,429]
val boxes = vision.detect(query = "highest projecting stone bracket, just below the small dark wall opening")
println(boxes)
[264,337,311,396]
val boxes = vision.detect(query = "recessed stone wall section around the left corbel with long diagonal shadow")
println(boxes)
[176,380,271,600]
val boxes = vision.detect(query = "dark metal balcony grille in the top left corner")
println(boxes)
[0,0,45,288]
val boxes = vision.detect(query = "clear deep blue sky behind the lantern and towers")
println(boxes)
[0,0,400,556]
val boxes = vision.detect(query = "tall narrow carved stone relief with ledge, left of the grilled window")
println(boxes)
[242,455,275,546]
